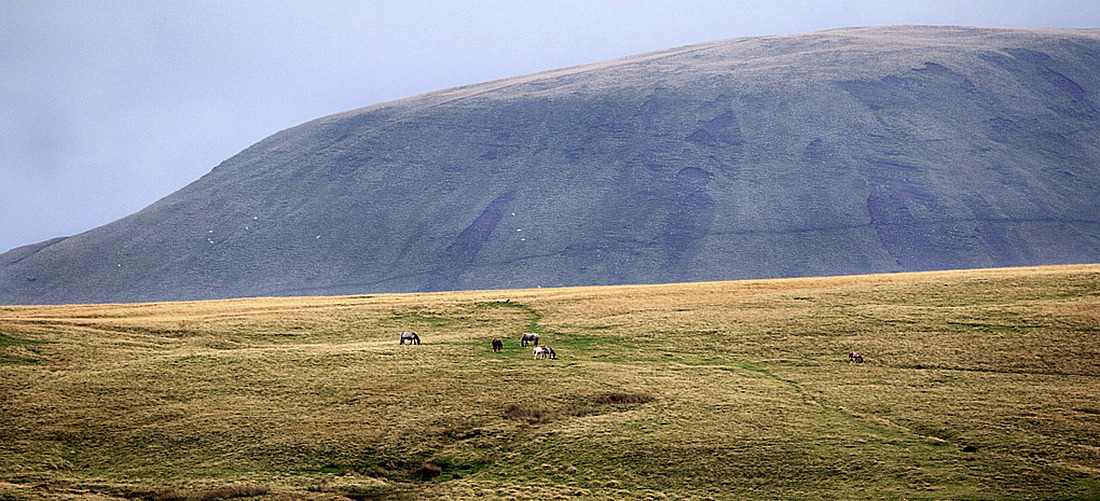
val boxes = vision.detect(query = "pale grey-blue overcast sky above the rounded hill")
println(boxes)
[0,0,1100,252]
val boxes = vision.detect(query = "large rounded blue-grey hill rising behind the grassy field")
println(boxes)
[0,26,1100,304]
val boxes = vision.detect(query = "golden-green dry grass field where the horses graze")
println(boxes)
[0,265,1100,500]
